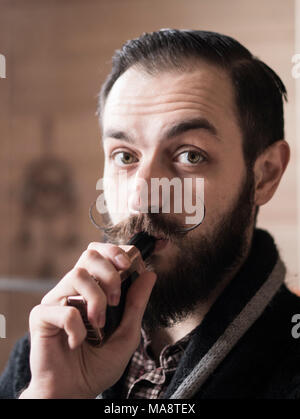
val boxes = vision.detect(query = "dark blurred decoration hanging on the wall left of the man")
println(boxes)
[12,156,79,279]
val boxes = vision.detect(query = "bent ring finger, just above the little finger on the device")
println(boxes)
[42,267,107,327]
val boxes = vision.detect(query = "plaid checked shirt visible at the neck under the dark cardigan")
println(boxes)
[123,329,193,399]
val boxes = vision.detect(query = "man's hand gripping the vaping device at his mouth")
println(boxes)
[20,243,156,398]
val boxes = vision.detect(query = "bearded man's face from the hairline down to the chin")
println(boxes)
[102,62,253,332]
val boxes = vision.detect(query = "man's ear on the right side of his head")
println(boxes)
[254,140,290,205]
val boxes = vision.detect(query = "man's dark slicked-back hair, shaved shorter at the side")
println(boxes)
[98,29,287,166]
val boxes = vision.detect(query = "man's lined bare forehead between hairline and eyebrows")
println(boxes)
[102,62,237,142]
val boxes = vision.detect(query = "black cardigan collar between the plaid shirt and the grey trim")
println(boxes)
[98,229,278,398]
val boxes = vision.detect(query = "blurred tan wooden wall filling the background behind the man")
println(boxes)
[0,0,300,370]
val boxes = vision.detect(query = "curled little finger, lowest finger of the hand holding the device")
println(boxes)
[29,304,86,349]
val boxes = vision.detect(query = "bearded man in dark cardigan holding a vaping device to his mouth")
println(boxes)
[0,30,300,399]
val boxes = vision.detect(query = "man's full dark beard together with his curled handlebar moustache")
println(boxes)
[105,173,254,333]
